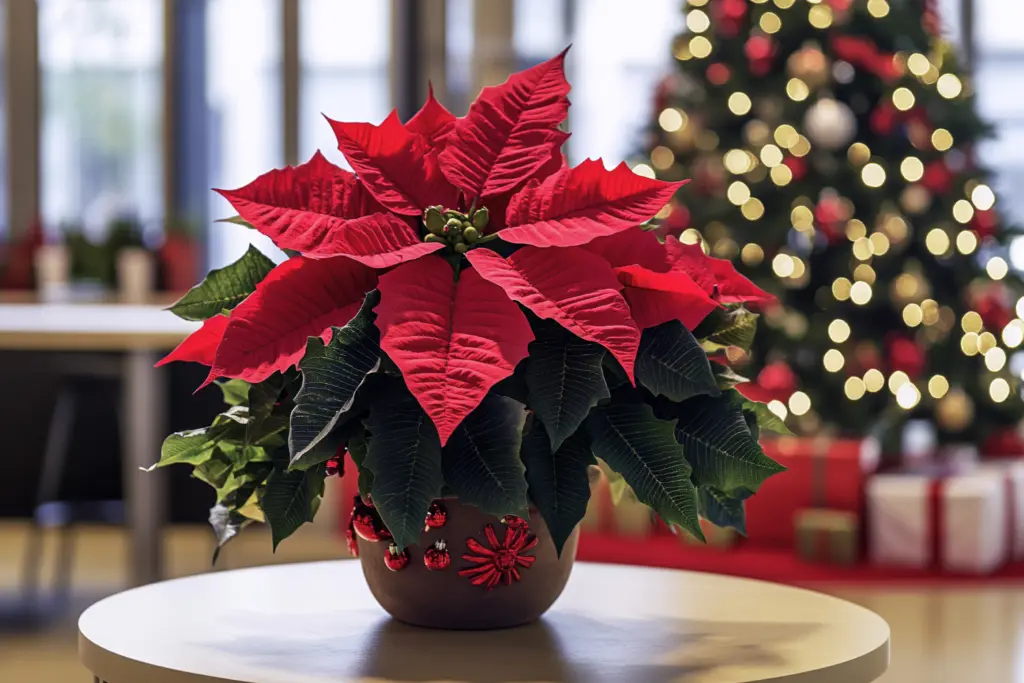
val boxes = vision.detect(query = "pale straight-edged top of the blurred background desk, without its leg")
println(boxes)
[0,303,200,351]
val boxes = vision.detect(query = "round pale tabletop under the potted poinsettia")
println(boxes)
[79,561,889,683]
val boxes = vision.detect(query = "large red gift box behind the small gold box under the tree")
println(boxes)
[746,437,880,548]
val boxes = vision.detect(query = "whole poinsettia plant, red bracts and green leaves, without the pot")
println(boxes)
[151,52,781,551]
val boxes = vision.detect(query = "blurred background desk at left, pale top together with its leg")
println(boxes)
[0,303,199,585]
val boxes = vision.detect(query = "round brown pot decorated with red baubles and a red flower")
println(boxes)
[358,499,579,630]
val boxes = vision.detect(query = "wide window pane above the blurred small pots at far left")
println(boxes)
[39,0,164,238]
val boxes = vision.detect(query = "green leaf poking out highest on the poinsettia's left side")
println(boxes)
[169,245,274,321]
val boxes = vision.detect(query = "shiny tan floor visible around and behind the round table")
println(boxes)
[0,524,1024,683]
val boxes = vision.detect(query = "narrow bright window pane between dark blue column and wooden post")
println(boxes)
[206,0,284,267]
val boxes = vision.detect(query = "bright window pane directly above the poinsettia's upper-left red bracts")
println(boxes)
[299,0,391,168]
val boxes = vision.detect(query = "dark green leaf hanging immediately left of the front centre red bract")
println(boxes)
[288,290,381,462]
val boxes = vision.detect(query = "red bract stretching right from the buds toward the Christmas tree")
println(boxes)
[502,159,683,247]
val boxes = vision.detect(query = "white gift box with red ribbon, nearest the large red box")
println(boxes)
[867,471,1009,573]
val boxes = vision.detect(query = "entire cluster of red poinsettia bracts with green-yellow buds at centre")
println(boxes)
[159,52,767,443]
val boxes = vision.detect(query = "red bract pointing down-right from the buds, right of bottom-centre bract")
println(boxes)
[467,247,640,380]
